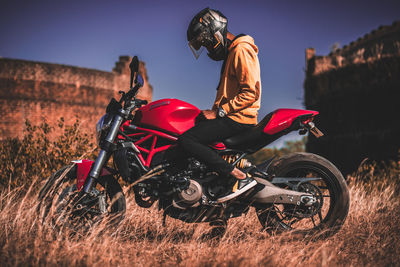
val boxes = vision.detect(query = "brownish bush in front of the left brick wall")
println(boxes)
[0,118,96,188]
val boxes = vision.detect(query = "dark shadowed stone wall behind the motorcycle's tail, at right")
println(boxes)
[304,21,400,176]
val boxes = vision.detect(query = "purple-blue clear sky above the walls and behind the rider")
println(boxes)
[0,0,400,146]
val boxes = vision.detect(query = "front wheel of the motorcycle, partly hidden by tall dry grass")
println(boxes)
[38,164,126,230]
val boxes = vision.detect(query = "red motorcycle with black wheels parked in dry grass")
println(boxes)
[39,57,349,237]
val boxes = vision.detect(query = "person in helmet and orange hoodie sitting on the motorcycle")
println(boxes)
[178,8,261,199]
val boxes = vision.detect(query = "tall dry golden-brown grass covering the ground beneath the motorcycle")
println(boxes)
[0,173,400,266]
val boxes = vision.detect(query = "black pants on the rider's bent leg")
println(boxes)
[178,117,252,175]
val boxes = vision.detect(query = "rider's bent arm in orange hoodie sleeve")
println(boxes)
[221,47,260,114]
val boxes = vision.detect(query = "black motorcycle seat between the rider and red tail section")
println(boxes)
[222,112,273,152]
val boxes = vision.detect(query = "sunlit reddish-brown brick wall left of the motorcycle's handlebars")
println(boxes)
[0,56,153,140]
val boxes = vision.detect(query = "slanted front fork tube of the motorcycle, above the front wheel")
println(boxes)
[83,114,123,193]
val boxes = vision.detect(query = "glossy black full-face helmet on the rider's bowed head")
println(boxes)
[187,7,230,61]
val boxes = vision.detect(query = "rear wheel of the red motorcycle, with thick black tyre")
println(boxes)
[257,153,350,237]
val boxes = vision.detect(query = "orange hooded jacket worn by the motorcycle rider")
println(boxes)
[213,35,261,124]
